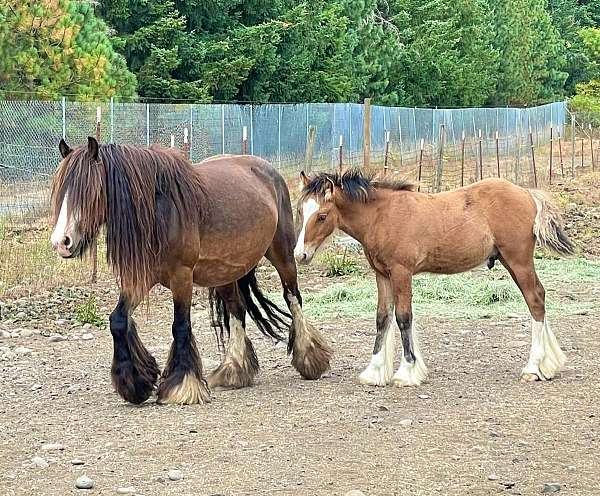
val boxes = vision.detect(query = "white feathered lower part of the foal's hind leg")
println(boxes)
[523,319,567,381]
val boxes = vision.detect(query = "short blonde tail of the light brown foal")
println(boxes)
[529,189,575,255]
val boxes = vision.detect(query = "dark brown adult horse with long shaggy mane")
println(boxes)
[51,138,331,404]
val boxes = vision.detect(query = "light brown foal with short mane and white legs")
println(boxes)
[295,170,573,386]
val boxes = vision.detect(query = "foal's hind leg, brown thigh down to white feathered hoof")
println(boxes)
[500,254,567,382]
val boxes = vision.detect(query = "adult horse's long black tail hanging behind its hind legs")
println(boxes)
[208,267,292,350]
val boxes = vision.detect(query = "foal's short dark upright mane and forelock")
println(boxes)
[301,169,415,203]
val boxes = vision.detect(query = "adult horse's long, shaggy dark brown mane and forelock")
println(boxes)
[52,145,210,295]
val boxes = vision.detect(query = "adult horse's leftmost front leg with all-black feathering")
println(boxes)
[110,293,160,404]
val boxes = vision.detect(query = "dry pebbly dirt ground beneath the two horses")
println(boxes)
[0,172,600,496]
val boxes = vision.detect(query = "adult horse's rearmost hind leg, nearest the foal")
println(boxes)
[265,228,333,379]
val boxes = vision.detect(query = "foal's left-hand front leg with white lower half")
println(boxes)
[358,273,395,386]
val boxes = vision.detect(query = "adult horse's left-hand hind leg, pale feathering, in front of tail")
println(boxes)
[208,283,259,388]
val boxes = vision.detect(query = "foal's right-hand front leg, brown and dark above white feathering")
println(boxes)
[392,269,427,387]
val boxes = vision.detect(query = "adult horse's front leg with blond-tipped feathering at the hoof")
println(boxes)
[157,267,210,405]
